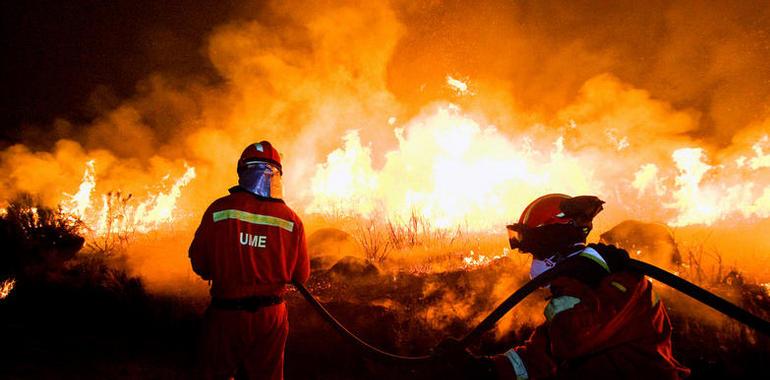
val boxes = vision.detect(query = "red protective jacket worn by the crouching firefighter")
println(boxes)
[492,246,689,380]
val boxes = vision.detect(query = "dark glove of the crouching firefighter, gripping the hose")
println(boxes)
[432,338,497,380]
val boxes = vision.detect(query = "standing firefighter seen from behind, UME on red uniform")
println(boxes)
[189,141,310,379]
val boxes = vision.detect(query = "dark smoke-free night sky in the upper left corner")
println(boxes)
[0,0,246,146]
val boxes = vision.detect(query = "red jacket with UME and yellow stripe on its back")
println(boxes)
[189,187,310,298]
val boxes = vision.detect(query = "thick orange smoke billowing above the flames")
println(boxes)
[2,1,770,202]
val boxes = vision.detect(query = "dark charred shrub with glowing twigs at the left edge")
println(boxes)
[0,194,145,321]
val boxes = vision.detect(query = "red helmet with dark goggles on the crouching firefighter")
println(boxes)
[507,194,604,257]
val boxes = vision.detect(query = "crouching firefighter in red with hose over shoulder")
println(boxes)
[442,194,689,380]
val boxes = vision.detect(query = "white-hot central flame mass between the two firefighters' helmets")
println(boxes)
[308,105,602,231]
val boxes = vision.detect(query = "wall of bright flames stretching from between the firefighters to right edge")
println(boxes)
[307,105,770,231]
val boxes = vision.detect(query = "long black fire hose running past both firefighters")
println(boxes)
[293,258,770,364]
